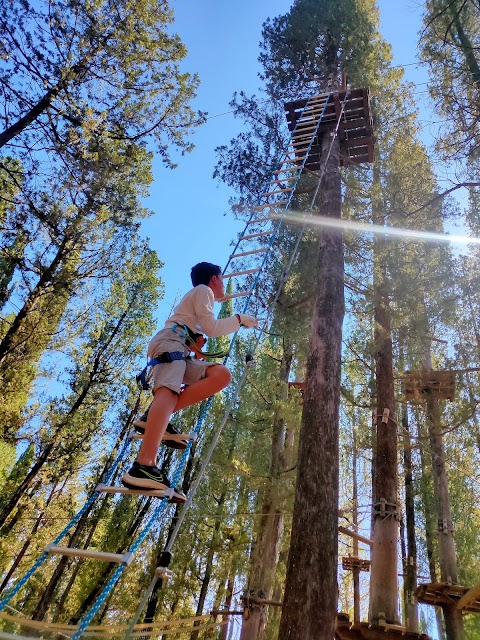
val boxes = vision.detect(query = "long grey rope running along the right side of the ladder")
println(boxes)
[122,89,347,640]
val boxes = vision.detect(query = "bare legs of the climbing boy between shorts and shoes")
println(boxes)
[137,365,232,466]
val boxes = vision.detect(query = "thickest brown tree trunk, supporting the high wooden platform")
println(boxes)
[278,126,344,640]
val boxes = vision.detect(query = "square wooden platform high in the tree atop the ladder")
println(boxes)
[285,89,374,171]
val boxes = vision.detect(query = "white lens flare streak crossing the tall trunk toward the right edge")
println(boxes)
[272,211,480,244]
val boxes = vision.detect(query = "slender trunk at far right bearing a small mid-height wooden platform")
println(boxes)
[425,342,464,640]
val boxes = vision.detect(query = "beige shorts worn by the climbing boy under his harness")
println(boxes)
[147,328,217,393]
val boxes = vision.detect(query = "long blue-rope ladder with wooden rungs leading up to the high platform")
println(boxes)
[0,94,341,640]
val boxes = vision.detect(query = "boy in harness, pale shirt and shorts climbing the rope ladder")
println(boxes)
[122,262,258,502]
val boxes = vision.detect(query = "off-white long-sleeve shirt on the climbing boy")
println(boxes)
[165,284,240,338]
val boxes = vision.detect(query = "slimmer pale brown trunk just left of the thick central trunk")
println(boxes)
[240,343,293,640]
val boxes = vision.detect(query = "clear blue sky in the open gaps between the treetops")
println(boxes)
[143,0,438,326]
